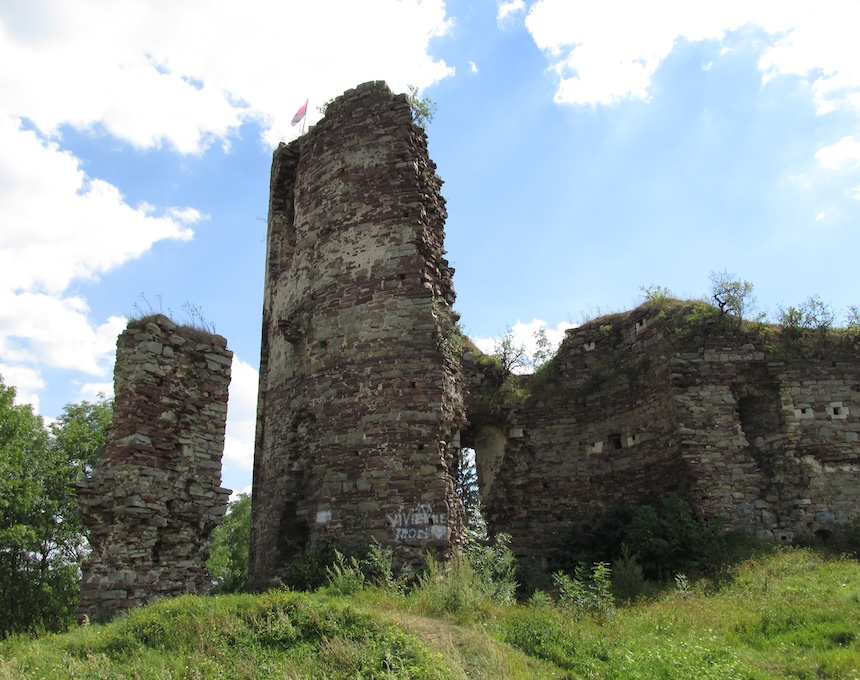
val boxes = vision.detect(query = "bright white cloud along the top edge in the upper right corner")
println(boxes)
[525,0,860,112]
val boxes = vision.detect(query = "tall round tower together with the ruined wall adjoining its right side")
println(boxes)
[250,82,860,589]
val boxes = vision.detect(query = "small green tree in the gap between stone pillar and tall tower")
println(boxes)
[206,493,251,593]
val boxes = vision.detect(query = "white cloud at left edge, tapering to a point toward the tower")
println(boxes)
[0,117,193,294]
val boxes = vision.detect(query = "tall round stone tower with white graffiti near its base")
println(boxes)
[249,82,463,589]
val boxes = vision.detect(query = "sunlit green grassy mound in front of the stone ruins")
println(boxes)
[0,548,860,680]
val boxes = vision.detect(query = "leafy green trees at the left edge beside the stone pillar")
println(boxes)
[0,378,110,636]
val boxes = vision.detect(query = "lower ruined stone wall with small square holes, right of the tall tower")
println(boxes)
[463,305,860,562]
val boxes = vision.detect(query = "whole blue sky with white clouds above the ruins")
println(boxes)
[0,0,860,489]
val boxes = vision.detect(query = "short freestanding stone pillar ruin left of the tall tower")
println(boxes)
[78,315,233,621]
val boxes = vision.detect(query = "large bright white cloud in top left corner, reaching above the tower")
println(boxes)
[0,0,452,153]
